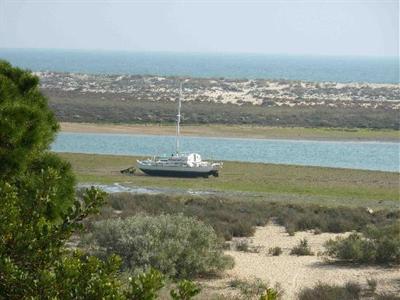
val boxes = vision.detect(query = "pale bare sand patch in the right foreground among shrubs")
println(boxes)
[205,224,400,299]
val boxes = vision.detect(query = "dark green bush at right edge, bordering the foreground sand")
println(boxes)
[325,223,400,264]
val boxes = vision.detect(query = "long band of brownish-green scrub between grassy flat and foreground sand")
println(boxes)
[95,193,400,240]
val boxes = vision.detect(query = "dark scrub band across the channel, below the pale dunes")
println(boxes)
[45,90,399,130]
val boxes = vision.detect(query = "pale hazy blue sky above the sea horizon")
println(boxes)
[0,0,399,56]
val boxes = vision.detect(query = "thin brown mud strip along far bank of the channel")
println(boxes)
[60,122,400,142]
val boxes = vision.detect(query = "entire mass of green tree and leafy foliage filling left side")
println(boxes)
[0,61,202,300]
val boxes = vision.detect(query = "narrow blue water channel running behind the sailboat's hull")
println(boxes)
[52,133,400,172]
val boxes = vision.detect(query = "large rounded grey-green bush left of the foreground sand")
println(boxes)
[89,215,228,278]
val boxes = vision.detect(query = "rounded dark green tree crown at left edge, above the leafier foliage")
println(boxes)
[0,61,58,178]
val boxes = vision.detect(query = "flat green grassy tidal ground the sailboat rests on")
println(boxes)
[60,153,399,206]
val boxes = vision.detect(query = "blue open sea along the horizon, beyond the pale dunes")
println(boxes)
[0,49,399,83]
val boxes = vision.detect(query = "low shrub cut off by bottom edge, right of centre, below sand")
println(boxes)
[299,283,361,300]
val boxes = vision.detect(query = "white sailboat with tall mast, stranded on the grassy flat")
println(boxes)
[137,82,223,178]
